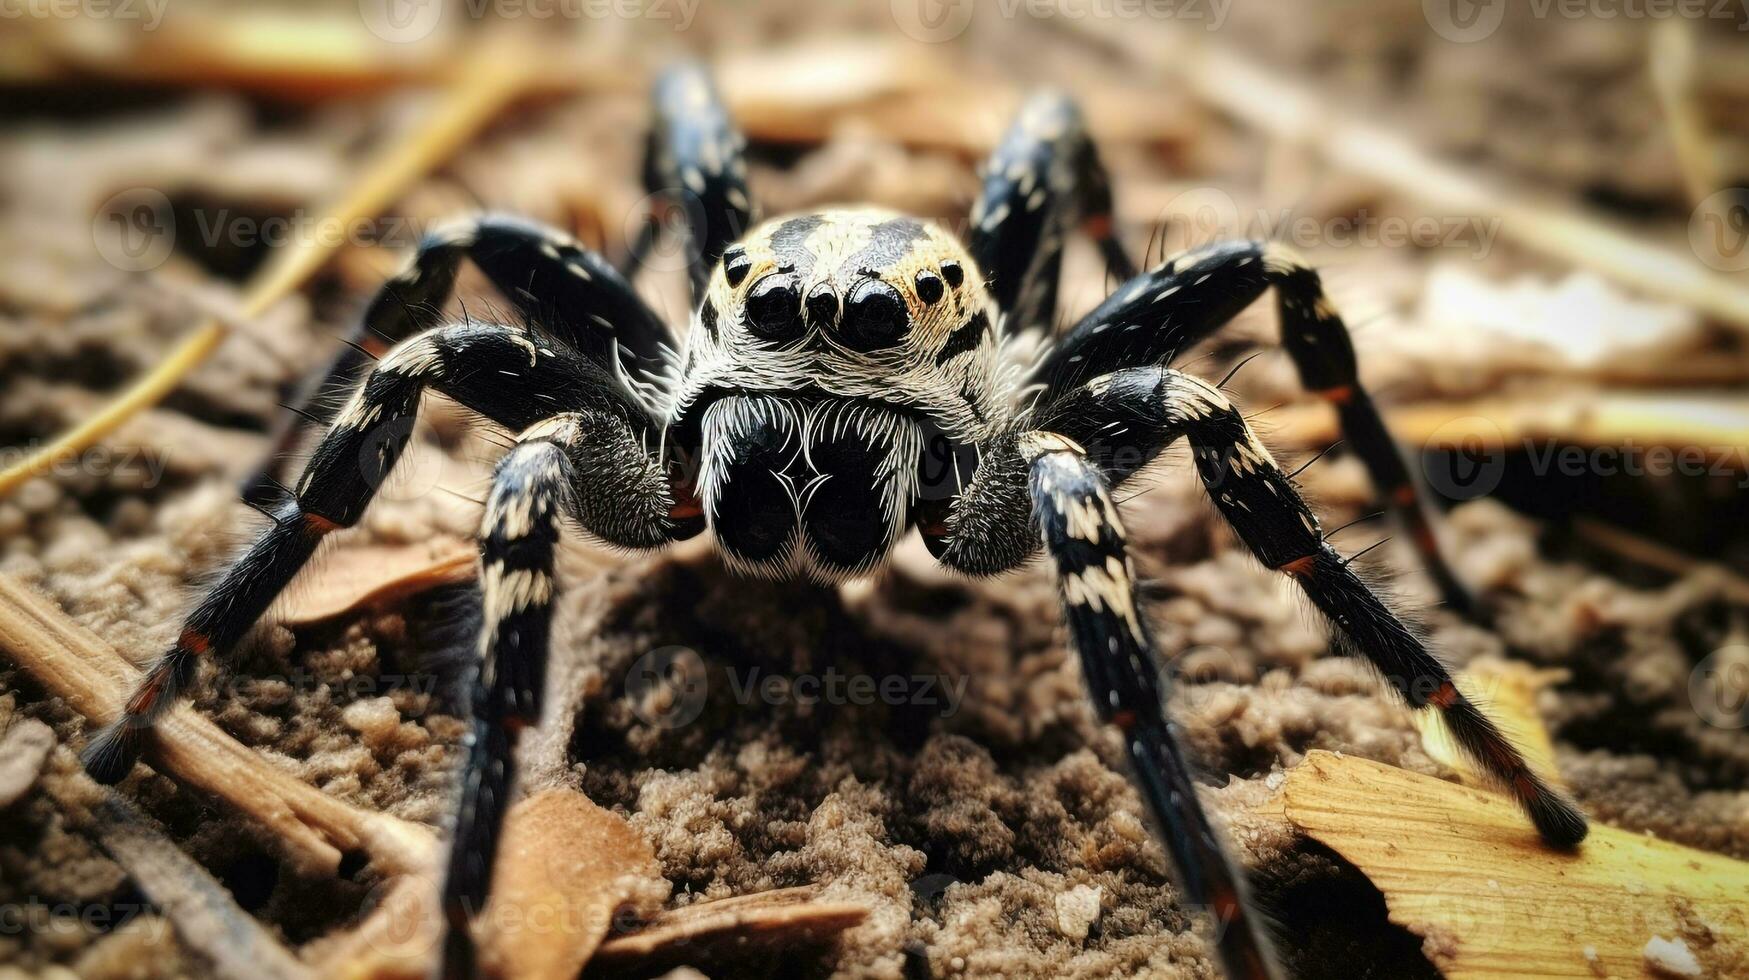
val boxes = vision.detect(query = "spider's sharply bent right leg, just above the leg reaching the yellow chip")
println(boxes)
[1030,242,1476,614]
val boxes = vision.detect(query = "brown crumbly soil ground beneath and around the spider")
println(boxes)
[0,4,1749,977]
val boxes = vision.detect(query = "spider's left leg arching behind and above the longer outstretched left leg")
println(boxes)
[243,215,673,504]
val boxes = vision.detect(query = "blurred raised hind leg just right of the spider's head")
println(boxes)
[967,91,1135,334]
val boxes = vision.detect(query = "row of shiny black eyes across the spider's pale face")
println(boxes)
[722,249,965,352]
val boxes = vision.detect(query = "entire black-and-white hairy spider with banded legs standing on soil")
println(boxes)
[84,67,1586,977]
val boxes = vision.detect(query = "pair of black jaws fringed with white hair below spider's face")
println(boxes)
[700,396,923,581]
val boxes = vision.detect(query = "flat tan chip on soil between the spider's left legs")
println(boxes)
[273,537,476,627]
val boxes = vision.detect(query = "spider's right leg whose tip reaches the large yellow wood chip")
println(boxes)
[1037,368,1586,847]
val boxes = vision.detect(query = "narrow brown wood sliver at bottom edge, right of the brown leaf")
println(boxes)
[595,886,869,970]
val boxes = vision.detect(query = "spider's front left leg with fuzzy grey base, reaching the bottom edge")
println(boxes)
[439,411,677,977]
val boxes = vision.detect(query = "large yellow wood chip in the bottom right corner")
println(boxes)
[1280,751,1749,978]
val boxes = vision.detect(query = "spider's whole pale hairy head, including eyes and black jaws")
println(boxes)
[672,208,1006,579]
